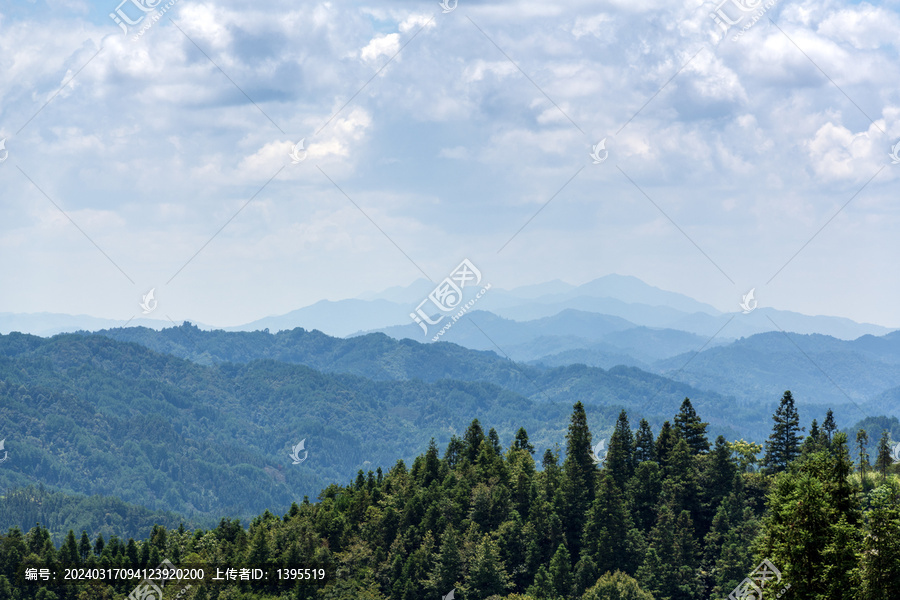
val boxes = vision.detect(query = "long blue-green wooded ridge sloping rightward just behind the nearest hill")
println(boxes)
[82,323,752,439]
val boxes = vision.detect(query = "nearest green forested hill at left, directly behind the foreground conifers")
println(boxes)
[0,334,632,516]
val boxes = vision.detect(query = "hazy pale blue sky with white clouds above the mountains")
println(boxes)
[0,0,900,326]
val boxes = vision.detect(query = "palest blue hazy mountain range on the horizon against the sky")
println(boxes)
[0,275,892,340]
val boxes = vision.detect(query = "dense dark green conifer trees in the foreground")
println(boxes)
[0,392,900,600]
